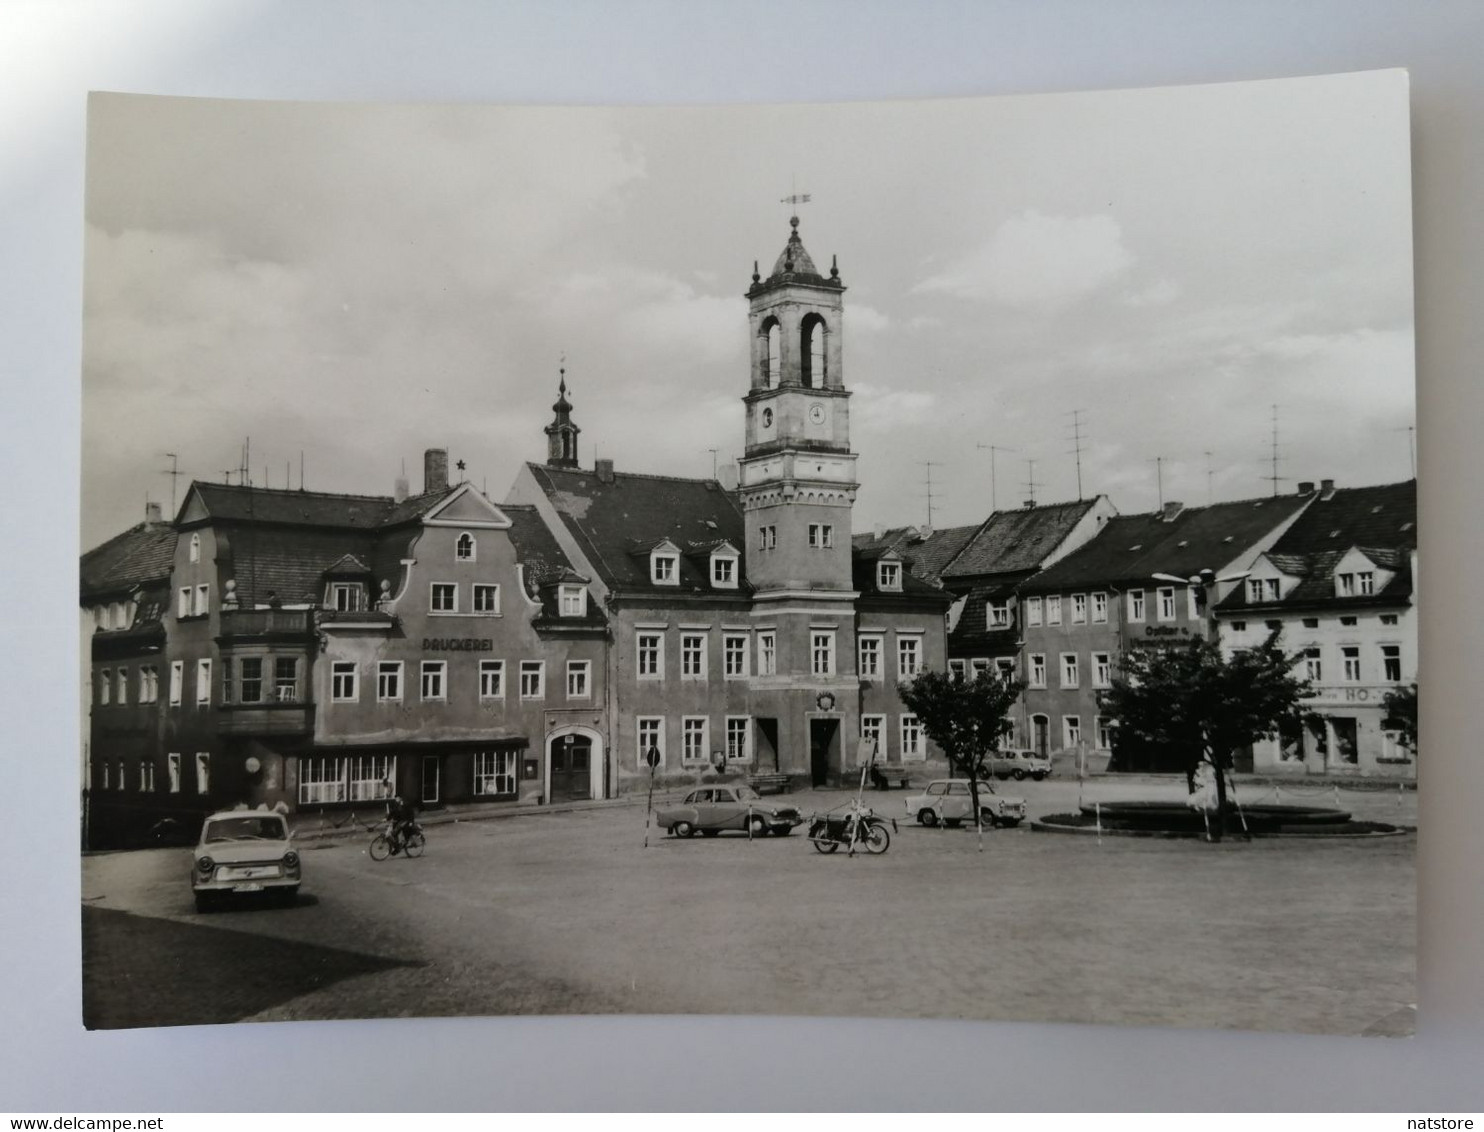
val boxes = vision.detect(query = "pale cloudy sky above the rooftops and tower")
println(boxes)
[83,71,1414,546]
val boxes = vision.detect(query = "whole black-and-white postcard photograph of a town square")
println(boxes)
[76,70,1431,1039]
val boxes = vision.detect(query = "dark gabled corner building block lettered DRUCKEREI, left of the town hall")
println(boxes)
[82,450,607,846]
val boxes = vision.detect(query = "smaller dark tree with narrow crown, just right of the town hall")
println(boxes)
[898,672,1025,842]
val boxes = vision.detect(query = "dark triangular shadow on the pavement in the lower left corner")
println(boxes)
[83,906,421,1030]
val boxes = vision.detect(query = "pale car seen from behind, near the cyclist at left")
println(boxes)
[190,810,301,912]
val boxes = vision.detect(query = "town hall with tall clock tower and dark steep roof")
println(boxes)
[506,217,950,789]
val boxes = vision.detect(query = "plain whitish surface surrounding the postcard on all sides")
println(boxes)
[0,0,1484,1113]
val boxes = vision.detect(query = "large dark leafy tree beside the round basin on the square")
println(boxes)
[1100,632,1313,840]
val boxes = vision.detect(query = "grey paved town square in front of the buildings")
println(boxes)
[83,779,1416,1034]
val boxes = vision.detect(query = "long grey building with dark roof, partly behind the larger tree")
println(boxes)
[1017,491,1315,770]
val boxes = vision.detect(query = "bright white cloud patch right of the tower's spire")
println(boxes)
[913,209,1134,307]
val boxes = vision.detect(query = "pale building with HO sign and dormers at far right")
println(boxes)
[1214,479,1417,777]
